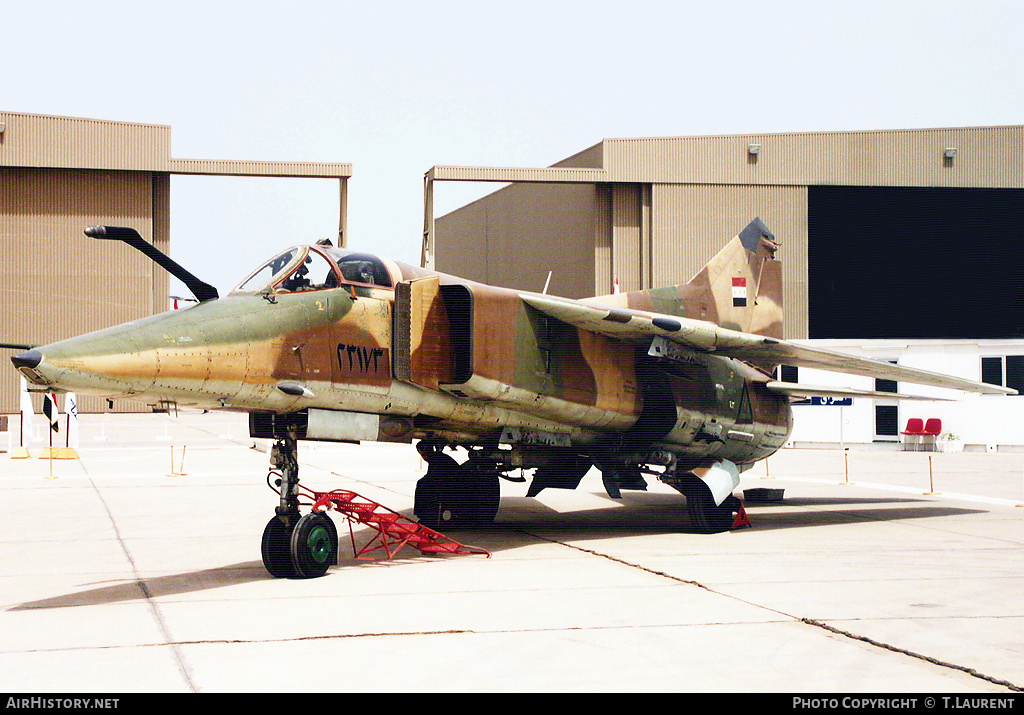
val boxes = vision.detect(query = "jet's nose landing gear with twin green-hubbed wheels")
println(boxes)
[260,428,338,579]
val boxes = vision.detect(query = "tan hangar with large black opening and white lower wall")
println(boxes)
[424,126,1024,450]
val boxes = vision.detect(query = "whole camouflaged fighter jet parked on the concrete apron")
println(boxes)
[11,219,1014,577]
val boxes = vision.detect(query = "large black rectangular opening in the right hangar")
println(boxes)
[807,186,1024,339]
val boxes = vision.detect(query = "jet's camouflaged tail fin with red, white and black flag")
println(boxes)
[584,218,782,339]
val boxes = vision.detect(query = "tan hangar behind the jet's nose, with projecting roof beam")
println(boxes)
[0,111,352,414]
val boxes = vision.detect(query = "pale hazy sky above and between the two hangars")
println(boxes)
[8,0,1024,292]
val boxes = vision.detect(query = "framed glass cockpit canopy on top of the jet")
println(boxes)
[232,246,394,293]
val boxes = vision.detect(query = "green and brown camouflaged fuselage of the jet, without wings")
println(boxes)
[22,239,792,466]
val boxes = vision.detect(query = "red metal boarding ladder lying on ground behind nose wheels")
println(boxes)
[299,486,490,560]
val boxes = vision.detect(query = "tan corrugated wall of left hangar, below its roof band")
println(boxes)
[0,167,159,412]
